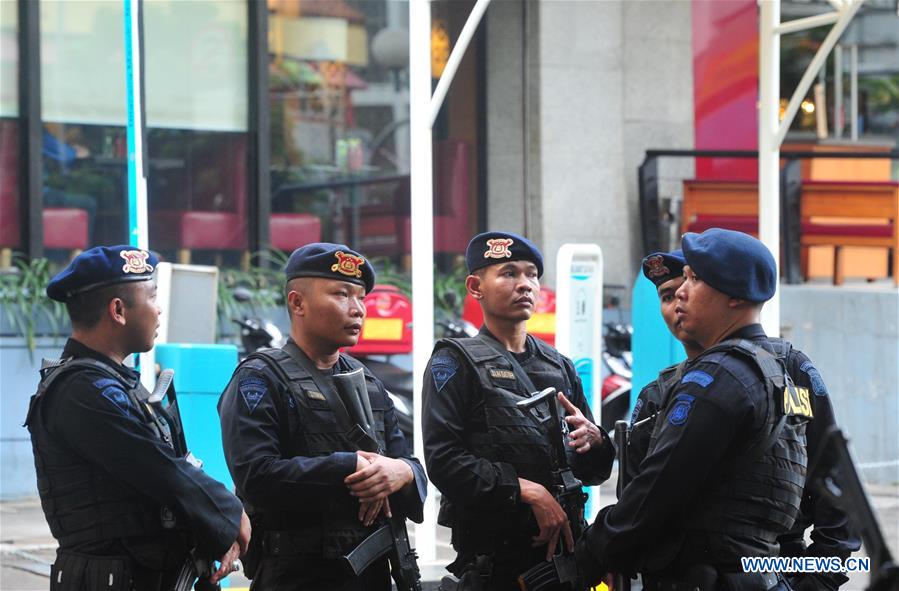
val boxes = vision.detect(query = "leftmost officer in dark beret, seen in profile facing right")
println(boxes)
[26,246,250,591]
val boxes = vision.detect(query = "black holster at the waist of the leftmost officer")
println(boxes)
[50,550,133,591]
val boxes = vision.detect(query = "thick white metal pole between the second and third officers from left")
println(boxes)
[409,0,437,563]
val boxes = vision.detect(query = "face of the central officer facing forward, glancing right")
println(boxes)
[468,261,540,322]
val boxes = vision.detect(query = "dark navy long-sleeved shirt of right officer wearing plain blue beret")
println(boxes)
[585,325,774,572]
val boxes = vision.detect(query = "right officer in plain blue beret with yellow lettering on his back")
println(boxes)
[577,229,812,591]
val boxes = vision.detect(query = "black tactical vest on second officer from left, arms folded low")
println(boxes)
[242,349,386,558]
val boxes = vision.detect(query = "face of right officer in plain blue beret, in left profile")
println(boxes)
[674,265,731,347]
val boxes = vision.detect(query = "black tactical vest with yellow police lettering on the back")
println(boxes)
[650,339,808,564]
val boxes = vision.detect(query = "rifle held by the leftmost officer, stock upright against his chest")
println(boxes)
[146,369,225,591]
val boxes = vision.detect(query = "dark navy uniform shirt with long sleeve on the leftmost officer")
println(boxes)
[42,339,243,557]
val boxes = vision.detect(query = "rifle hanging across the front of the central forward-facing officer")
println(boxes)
[517,388,587,591]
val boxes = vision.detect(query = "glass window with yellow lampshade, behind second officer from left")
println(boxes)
[268,0,409,259]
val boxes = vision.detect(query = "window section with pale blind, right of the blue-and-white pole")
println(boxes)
[144,0,255,266]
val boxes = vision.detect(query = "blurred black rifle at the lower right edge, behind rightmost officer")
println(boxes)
[809,426,899,591]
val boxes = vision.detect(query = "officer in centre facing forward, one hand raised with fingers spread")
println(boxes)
[422,232,614,589]
